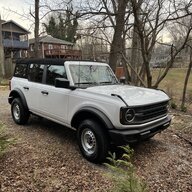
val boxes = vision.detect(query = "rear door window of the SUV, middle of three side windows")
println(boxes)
[28,64,44,83]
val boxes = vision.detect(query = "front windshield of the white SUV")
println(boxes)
[69,65,118,87]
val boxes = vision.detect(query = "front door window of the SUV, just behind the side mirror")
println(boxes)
[46,65,67,85]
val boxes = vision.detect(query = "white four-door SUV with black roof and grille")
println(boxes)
[8,59,171,162]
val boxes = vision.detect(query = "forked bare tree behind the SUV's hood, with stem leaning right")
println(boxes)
[131,0,191,88]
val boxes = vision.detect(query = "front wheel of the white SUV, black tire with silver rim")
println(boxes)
[77,120,109,163]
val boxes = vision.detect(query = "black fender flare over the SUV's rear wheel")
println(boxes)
[8,88,28,109]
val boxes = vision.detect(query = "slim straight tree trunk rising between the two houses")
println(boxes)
[34,0,39,58]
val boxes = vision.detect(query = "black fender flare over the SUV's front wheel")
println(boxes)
[71,107,114,129]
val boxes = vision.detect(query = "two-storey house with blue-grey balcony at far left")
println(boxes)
[0,19,30,77]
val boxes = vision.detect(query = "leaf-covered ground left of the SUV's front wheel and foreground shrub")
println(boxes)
[0,90,109,192]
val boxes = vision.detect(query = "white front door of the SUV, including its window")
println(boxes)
[40,65,71,124]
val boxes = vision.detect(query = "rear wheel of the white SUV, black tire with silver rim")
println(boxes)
[11,98,29,125]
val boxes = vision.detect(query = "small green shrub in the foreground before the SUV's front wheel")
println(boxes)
[105,146,147,192]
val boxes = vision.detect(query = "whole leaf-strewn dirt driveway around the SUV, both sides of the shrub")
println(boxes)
[0,89,192,192]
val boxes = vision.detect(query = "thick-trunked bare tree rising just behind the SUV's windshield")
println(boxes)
[74,0,130,71]
